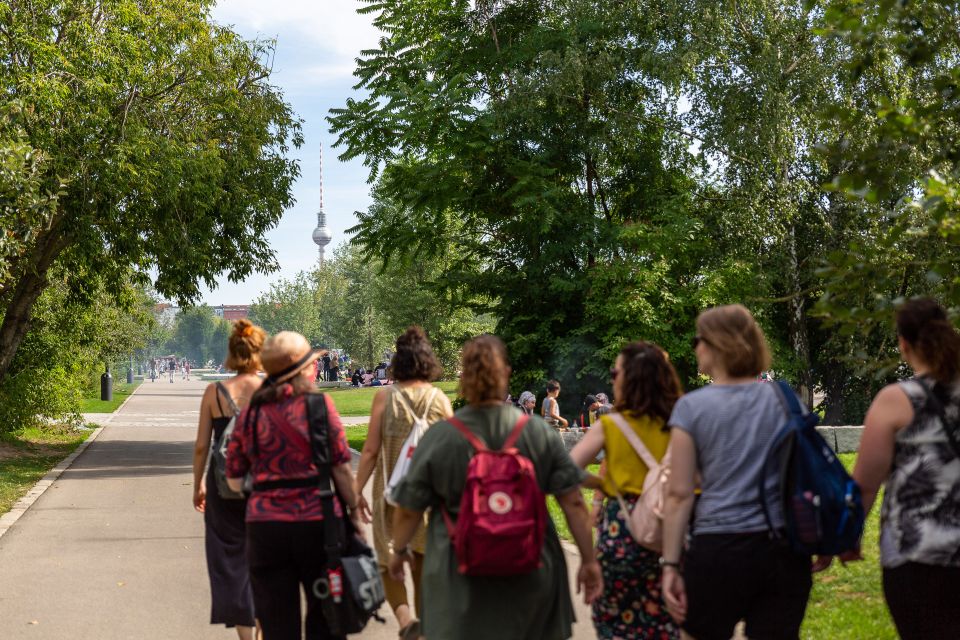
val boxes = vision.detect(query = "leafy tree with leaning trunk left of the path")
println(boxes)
[0,0,301,377]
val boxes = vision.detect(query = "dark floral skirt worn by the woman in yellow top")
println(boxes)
[593,497,680,640]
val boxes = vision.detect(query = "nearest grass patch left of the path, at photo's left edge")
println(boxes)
[0,426,90,514]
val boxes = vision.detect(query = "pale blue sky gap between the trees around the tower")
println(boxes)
[197,0,379,305]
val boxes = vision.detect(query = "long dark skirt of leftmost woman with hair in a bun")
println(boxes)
[203,462,254,627]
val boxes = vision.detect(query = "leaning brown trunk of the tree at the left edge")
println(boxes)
[0,224,68,380]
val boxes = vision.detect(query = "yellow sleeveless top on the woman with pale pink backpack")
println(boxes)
[592,412,670,496]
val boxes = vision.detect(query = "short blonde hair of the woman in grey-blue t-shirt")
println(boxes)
[697,304,770,378]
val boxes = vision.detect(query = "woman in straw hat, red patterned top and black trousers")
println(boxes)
[227,331,357,640]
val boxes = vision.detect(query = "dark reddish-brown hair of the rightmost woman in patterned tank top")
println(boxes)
[897,298,960,384]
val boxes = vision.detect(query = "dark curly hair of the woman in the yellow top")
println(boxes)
[614,340,683,428]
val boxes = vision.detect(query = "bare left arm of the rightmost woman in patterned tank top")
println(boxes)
[853,385,913,514]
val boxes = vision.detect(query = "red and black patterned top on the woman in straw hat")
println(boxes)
[226,385,350,522]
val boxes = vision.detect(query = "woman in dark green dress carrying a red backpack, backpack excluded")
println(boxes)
[389,335,602,640]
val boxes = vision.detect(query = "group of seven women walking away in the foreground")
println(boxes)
[194,300,960,640]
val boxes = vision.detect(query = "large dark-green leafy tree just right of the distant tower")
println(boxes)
[330,0,694,400]
